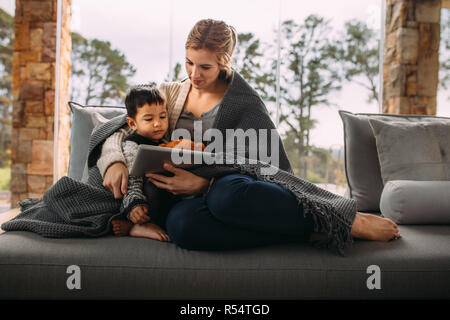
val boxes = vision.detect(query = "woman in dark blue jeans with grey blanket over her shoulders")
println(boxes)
[97,19,400,250]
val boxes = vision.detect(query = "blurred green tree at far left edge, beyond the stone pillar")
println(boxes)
[0,9,14,167]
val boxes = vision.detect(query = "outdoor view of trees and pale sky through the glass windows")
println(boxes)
[0,0,450,210]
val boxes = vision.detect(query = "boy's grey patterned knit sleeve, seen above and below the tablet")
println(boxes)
[122,141,149,219]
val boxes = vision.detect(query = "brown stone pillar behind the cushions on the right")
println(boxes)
[383,0,441,115]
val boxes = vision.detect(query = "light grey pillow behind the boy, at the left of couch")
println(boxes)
[67,101,126,181]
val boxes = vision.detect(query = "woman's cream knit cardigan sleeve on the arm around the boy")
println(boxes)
[97,125,132,177]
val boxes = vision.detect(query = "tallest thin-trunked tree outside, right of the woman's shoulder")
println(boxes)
[272,15,341,178]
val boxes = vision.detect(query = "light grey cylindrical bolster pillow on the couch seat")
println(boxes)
[380,180,450,224]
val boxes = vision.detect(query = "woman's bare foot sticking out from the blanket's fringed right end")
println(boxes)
[350,212,400,241]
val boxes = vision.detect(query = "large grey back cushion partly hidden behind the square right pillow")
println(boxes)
[339,110,450,212]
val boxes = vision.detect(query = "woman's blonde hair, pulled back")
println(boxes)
[185,19,237,79]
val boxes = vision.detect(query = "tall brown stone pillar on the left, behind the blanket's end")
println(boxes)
[10,0,71,207]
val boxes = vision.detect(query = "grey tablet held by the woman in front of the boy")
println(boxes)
[130,144,214,176]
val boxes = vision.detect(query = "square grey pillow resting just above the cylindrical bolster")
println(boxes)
[369,119,450,183]
